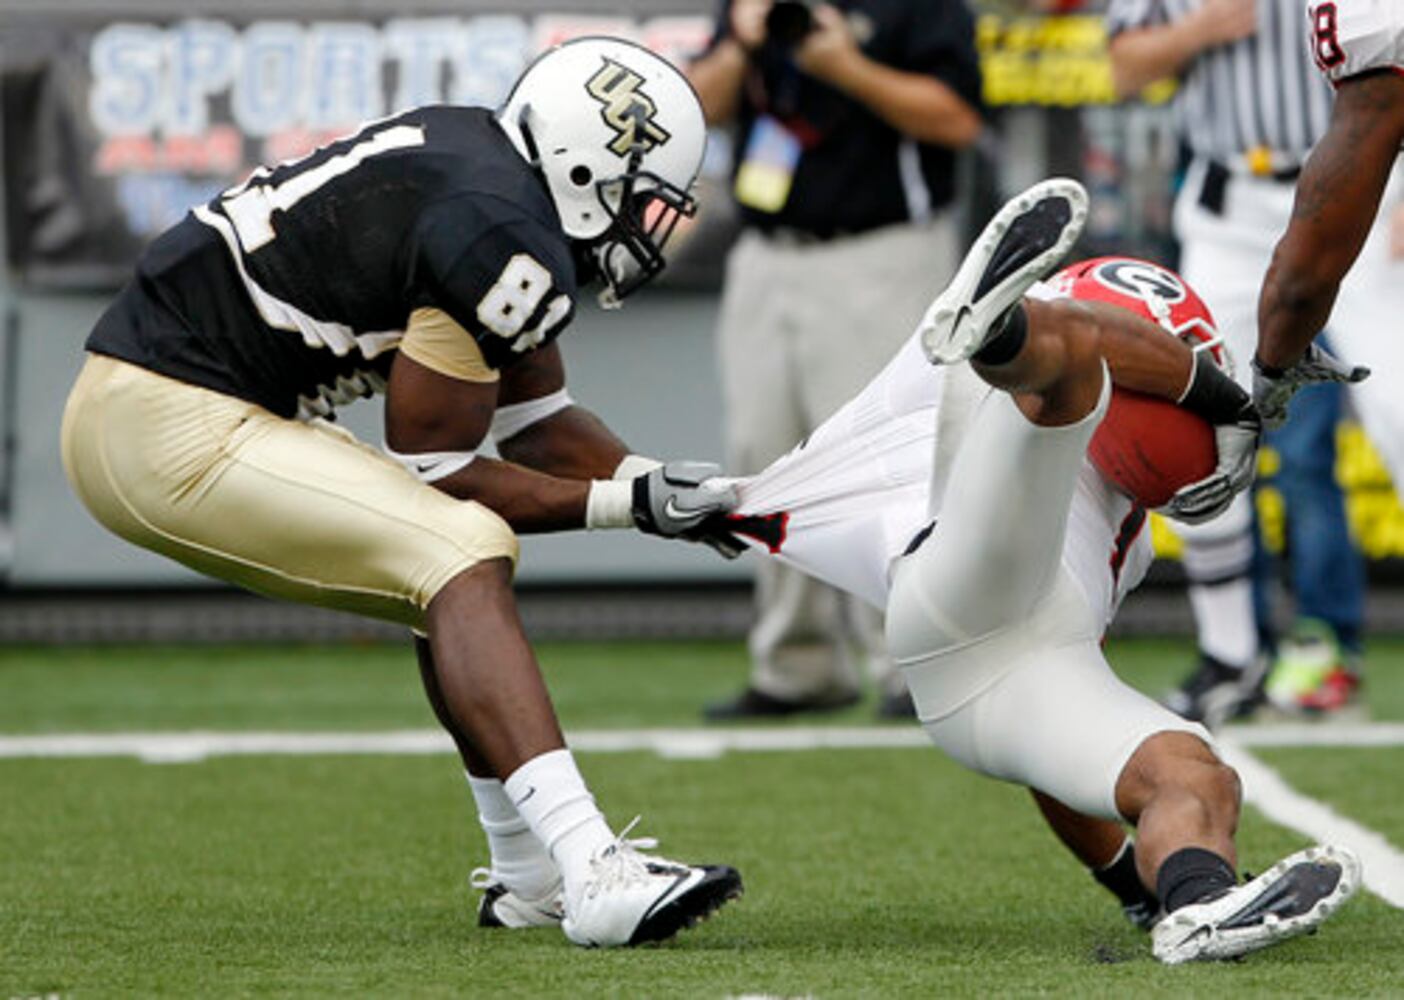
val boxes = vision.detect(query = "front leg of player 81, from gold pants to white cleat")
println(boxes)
[63,358,740,945]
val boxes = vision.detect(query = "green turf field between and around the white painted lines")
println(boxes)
[0,640,1404,1000]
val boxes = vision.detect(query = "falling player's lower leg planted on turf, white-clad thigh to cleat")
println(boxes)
[927,637,1359,962]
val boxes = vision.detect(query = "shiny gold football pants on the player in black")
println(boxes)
[62,355,517,628]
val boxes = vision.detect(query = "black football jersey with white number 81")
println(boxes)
[87,107,576,416]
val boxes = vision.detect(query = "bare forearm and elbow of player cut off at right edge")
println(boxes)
[1257,72,1404,375]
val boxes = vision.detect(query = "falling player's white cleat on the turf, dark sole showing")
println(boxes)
[1151,846,1360,965]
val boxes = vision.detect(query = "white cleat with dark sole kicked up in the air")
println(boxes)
[917,177,1087,365]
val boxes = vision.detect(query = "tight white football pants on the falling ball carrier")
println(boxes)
[887,369,1207,819]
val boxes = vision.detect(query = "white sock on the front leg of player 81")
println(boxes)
[503,750,614,895]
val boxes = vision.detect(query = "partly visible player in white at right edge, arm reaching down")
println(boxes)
[1252,0,1404,421]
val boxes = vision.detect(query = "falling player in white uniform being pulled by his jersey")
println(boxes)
[729,180,1360,963]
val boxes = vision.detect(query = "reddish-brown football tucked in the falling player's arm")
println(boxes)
[1087,389,1217,507]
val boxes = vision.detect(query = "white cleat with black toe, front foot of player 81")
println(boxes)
[560,819,741,948]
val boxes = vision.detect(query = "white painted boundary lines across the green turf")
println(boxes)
[0,723,1404,909]
